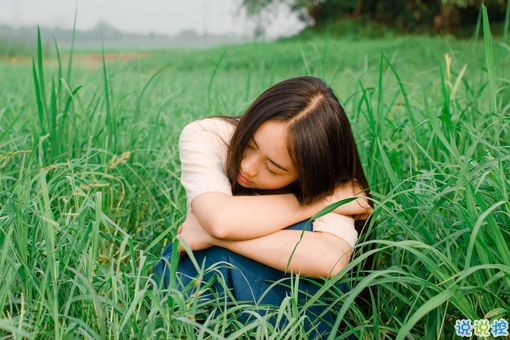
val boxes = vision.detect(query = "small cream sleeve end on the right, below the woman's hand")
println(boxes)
[313,213,358,247]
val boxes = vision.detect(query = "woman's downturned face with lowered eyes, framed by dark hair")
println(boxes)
[237,120,297,190]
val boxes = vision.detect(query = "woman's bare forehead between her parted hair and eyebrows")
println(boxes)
[253,120,293,170]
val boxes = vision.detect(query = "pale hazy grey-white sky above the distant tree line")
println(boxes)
[0,0,302,36]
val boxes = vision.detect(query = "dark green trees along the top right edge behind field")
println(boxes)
[242,0,510,33]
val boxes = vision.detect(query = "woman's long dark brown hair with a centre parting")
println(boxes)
[226,77,370,205]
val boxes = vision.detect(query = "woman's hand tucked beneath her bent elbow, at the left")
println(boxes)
[177,213,215,253]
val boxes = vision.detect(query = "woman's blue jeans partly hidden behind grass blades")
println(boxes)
[155,221,348,338]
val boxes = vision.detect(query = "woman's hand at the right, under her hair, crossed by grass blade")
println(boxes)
[325,182,374,220]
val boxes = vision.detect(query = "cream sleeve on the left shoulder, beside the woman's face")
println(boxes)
[179,121,232,211]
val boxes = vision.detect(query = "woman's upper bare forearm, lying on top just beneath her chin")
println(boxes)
[191,192,318,240]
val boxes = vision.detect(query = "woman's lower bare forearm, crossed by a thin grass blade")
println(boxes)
[215,230,351,277]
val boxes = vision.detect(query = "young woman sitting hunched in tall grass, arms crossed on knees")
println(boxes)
[156,77,372,338]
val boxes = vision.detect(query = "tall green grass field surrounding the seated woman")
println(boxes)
[0,19,510,339]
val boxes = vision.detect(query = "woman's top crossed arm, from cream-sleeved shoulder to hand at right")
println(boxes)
[179,119,368,240]
